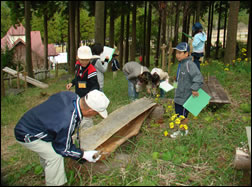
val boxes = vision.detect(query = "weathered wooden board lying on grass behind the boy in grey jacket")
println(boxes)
[202,76,230,104]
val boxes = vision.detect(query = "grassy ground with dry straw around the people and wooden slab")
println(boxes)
[1,57,251,186]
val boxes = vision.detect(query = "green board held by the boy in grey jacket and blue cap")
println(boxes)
[183,88,211,116]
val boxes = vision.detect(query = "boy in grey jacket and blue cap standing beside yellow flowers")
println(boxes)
[174,42,203,137]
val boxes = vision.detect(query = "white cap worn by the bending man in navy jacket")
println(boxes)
[85,90,109,118]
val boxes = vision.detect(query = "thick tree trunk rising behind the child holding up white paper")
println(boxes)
[95,1,105,46]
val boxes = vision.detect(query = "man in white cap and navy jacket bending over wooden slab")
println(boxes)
[14,90,110,186]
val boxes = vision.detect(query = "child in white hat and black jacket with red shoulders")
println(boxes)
[66,46,100,97]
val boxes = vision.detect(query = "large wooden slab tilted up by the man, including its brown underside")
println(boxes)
[80,98,156,156]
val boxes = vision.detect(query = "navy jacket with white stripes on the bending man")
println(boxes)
[14,91,83,159]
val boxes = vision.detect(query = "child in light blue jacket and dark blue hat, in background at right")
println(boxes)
[192,22,207,70]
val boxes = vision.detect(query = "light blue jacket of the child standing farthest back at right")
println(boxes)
[192,32,207,53]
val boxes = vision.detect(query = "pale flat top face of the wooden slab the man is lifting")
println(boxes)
[80,97,156,150]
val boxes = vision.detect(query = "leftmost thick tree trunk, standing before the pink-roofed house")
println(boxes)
[25,1,34,78]
